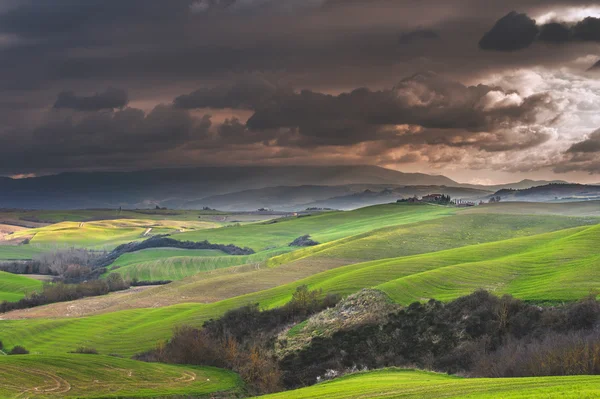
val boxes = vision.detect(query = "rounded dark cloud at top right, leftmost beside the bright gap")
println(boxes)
[479,11,539,51]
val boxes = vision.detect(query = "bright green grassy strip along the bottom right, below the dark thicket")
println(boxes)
[261,369,600,399]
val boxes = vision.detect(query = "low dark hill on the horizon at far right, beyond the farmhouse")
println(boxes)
[494,183,600,202]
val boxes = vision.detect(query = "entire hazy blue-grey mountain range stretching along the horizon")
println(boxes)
[0,165,592,211]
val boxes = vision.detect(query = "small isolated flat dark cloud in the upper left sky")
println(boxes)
[54,89,129,111]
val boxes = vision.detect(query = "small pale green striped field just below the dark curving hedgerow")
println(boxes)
[110,248,291,281]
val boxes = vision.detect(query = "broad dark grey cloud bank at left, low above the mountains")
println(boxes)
[0,105,211,170]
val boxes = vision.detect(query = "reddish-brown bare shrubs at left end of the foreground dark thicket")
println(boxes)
[137,286,339,394]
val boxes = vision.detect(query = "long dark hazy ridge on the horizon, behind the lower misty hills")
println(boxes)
[0,165,458,209]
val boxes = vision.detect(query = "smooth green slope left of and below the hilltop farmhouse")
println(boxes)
[173,204,456,251]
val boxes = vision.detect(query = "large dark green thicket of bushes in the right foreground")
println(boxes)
[279,291,600,387]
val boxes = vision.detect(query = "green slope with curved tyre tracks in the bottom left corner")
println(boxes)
[0,355,241,398]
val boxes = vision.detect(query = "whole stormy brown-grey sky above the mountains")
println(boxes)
[0,0,600,184]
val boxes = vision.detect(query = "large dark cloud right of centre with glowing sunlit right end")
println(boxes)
[247,74,549,144]
